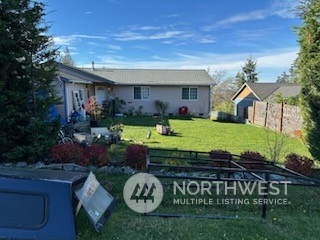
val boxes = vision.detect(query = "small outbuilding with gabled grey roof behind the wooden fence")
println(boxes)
[232,83,300,118]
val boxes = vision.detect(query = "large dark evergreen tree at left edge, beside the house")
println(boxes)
[0,0,59,161]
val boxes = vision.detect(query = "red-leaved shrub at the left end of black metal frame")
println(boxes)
[125,144,148,170]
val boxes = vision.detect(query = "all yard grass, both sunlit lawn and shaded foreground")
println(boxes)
[77,117,320,240]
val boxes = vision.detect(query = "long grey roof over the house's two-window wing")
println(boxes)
[81,68,214,86]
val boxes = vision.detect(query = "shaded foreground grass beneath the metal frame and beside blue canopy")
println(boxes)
[77,175,320,240]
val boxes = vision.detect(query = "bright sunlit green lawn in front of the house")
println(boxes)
[107,116,310,160]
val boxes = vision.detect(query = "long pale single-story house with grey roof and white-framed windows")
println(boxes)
[55,63,213,118]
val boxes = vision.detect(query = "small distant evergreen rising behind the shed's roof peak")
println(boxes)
[236,56,259,87]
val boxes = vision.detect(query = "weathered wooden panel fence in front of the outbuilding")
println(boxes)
[248,102,302,136]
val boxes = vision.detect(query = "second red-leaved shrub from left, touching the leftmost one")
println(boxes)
[83,144,110,167]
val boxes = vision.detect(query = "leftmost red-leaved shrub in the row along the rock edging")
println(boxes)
[48,143,84,164]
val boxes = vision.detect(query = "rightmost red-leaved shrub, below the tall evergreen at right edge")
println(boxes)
[284,153,314,176]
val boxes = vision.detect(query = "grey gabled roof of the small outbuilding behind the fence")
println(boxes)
[232,83,300,101]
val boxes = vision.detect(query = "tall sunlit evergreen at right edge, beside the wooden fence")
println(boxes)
[297,0,320,160]
